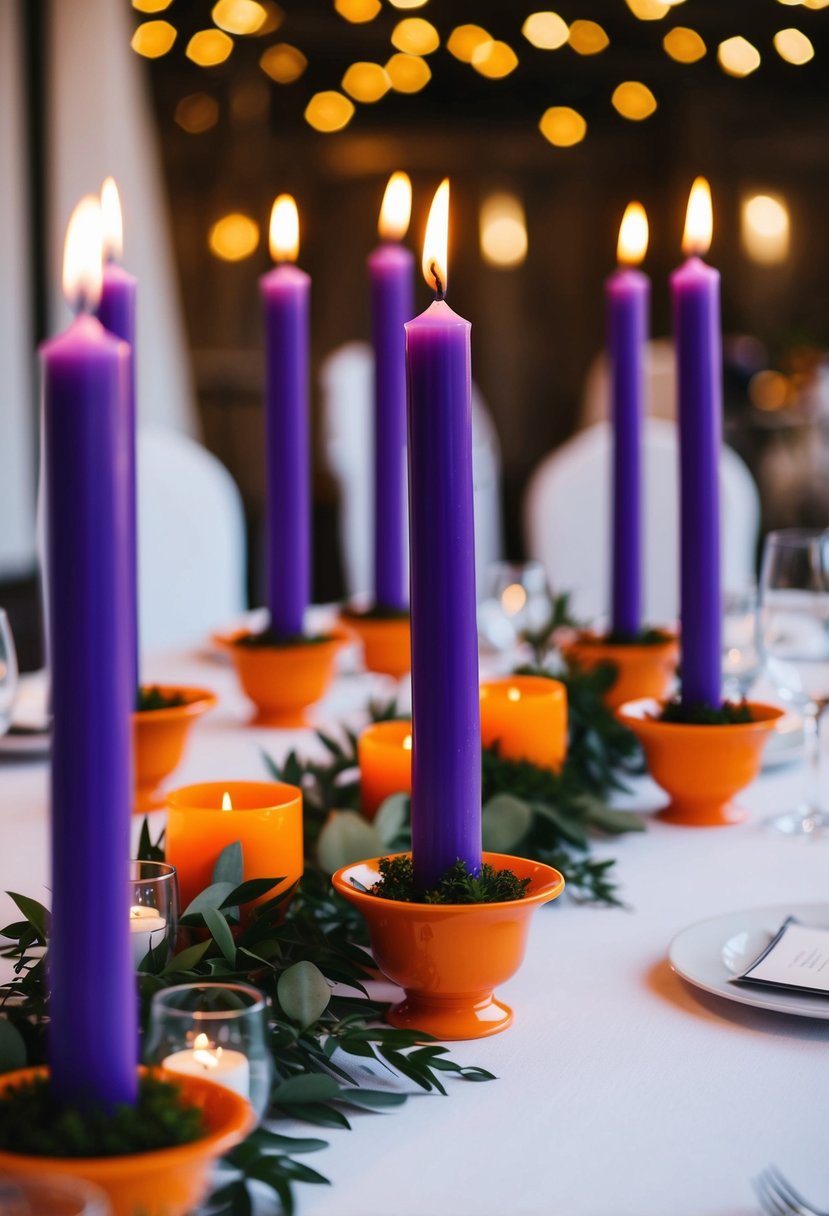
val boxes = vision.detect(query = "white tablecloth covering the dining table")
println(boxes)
[0,654,829,1216]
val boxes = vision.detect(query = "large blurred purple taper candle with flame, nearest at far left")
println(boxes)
[41,197,137,1108]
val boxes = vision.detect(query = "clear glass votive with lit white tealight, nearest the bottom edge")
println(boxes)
[145,984,272,1119]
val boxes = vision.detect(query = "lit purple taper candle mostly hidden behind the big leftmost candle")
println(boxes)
[97,178,140,688]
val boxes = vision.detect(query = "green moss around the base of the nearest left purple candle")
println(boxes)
[0,1076,205,1158]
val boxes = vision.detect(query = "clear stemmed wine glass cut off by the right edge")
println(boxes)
[760,528,829,837]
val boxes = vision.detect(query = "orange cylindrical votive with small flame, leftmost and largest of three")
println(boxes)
[165,781,304,912]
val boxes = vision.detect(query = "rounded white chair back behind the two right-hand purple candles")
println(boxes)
[524,418,760,625]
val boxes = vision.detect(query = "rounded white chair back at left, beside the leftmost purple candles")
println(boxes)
[137,427,247,651]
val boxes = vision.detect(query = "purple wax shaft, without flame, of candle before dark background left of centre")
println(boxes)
[260,263,311,637]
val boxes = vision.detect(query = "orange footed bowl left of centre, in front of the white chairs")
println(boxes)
[215,627,351,727]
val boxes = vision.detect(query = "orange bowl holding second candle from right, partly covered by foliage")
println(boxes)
[562,629,679,709]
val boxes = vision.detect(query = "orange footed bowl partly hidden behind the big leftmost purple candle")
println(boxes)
[132,685,218,815]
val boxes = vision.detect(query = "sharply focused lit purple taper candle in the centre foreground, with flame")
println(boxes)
[406,181,481,890]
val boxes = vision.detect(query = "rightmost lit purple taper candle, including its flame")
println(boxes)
[671,178,722,706]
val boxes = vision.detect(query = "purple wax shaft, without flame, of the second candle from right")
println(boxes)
[605,268,650,637]
